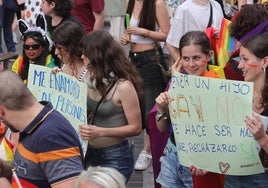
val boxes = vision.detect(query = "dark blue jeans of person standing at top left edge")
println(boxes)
[0,0,16,53]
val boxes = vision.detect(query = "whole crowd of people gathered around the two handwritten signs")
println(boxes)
[0,0,268,188]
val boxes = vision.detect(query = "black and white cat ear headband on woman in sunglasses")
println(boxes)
[18,14,53,51]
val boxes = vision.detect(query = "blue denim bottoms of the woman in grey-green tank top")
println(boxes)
[86,140,134,183]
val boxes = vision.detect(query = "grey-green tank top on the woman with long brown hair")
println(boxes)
[87,80,128,128]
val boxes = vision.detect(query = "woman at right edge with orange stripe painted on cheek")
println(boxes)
[225,35,268,188]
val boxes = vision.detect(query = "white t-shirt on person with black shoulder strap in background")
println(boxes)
[166,0,223,48]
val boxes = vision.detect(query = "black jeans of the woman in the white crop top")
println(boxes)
[129,49,166,131]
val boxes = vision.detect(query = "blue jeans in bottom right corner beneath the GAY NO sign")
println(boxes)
[224,171,268,188]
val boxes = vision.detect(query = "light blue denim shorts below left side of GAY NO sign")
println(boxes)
[156,142,193,188]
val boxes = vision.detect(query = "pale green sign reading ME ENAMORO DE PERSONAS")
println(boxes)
[28,64,87,153]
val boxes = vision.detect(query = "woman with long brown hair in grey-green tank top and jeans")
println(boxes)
[79,31,142,182]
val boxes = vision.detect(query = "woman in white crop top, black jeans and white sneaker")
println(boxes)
[121,0,170,170]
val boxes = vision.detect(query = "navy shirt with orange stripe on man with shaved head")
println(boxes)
[14,102,83,187]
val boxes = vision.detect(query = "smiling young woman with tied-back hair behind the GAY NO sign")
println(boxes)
[155,31,224,188]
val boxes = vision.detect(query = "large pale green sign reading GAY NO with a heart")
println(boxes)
[169,72,263,175]
